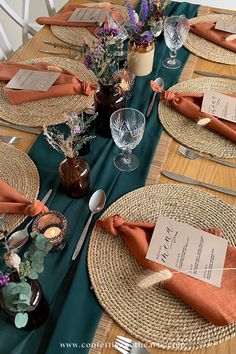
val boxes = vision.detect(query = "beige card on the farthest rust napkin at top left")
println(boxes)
[68,8,110,23]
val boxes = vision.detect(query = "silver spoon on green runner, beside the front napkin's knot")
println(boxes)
[72,189,106,261]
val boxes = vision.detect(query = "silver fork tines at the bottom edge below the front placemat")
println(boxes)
[114,336,150,354]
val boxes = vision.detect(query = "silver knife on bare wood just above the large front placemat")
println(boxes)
[161,171,236,197]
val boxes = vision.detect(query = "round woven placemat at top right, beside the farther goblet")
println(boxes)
[184,14,236,65]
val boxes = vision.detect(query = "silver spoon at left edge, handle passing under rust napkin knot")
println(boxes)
[7,189,52,249]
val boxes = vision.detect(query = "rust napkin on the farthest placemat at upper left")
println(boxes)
[36,2,121,36]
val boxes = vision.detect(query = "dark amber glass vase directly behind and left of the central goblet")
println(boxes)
[94,82,125,138]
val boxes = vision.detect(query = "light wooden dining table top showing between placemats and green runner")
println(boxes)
[0,0,236,354]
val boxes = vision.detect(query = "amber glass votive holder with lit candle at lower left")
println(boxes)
[32,210,67,251]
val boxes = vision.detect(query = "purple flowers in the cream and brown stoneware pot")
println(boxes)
[125,0,169,47]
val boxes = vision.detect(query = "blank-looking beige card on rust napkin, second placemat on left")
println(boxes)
[5,69,61,92]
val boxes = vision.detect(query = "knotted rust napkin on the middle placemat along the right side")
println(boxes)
[150,81,236,142]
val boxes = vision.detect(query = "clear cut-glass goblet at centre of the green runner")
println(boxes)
[110,108,145,171]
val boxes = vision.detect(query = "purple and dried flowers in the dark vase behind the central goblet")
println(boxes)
[83,26,120,85]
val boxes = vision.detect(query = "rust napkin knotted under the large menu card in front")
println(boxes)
[97,215,236,326]
